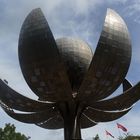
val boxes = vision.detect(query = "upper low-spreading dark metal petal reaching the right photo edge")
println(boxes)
[90,83,140,111]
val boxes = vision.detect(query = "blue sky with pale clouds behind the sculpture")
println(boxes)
[0,0,140,140]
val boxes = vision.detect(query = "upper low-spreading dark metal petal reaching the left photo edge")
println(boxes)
[0,79,55,112]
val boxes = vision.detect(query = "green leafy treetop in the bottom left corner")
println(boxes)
[0,124,29,140]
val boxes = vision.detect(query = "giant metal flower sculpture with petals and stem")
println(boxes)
[0,9,140,140]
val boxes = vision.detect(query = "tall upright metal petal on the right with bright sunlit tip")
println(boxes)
[78,9,131,101]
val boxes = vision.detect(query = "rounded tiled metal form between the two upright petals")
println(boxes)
[56,38,93,92]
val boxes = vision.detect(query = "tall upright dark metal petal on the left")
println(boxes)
[19,9,72,101]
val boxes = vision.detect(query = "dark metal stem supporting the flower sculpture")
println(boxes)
[59,102,81,140]
